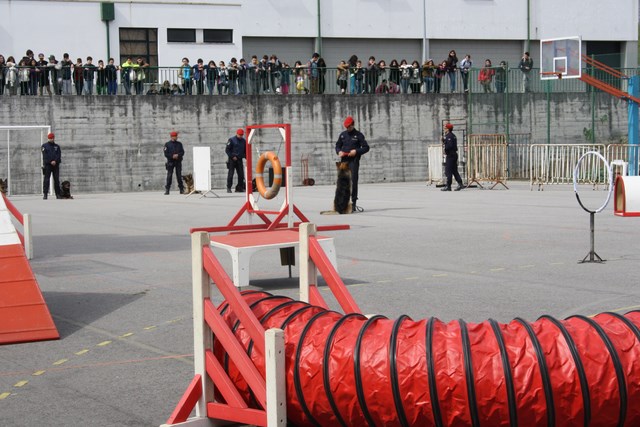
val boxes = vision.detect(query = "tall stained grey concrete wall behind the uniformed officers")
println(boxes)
[0,93,627,194]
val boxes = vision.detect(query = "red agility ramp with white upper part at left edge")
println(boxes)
[0,195,60,344]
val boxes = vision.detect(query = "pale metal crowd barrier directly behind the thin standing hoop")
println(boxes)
[529,144,607,190]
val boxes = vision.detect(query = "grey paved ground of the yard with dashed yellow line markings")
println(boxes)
[0,183,640,426]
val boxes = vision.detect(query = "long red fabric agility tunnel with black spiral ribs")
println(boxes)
[214,291,640,427]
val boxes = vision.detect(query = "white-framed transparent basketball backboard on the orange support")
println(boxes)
[540,36,582,80]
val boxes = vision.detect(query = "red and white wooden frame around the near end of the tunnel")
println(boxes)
[163,223,360,427]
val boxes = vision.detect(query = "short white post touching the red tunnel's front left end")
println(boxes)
[264,328,287,427]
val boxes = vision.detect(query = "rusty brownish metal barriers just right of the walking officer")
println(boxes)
[467,134,509,189]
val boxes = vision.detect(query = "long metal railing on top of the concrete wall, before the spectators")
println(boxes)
[4,67,638,95]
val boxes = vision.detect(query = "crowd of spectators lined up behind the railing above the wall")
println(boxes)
[0,50,533,95]
